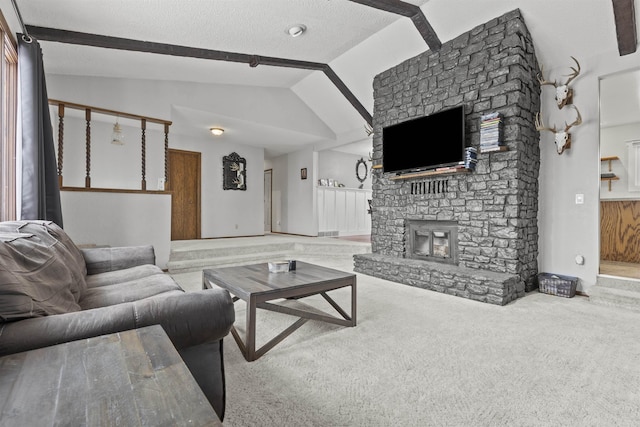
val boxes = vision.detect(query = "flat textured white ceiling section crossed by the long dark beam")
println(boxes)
[18,0,427,87]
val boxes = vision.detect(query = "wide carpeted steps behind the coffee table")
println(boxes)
[167,235,371,274]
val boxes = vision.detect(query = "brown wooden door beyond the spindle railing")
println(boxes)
[169,150,200,240]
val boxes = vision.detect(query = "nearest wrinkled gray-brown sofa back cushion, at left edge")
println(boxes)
[0,230,84,322]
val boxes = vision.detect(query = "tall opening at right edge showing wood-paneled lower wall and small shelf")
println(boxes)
[600,68,640,278]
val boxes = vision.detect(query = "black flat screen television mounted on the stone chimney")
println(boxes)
[382,105,465,174]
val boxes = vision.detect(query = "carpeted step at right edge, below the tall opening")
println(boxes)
[589,275,640,312]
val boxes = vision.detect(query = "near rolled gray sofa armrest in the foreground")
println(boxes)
[0,289,235,355]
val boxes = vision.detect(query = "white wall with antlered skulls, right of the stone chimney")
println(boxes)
[538,46,638,293]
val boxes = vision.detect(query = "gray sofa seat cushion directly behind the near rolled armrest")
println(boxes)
[80,267,184,310]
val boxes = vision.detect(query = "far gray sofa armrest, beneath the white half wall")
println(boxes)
[81,245,156,274]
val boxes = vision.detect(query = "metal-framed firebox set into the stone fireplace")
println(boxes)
[405,220,458,265]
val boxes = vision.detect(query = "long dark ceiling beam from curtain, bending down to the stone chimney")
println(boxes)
[26,25,373,125]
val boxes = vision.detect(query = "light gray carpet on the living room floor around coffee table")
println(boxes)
[171,252,640,427]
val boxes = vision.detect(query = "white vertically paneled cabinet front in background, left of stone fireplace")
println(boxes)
[317,187,371,236]
